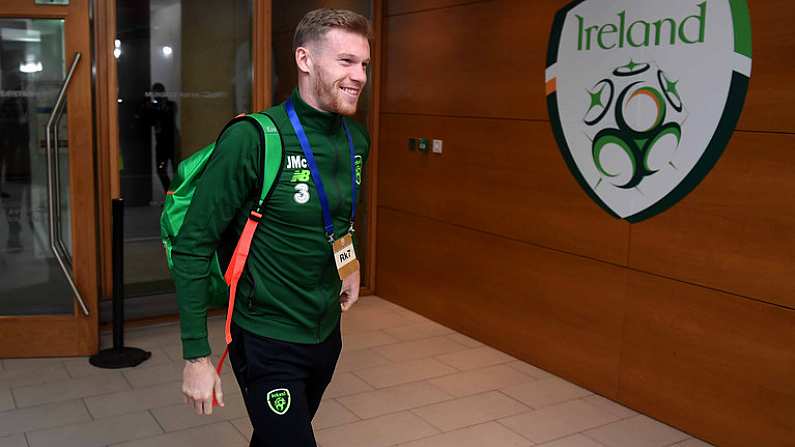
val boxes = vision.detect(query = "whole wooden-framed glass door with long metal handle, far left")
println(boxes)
[0,0,98,357]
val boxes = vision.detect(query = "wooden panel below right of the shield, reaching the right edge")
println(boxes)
[630,132,795,309]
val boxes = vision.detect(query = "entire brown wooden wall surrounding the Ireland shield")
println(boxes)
[376,0,795,446]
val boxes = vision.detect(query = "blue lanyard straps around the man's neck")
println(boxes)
[284,99,356,242]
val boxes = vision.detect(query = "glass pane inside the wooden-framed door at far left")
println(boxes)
[0,19,74,315]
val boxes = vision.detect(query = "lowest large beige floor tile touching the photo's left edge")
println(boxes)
[0,400,91,436]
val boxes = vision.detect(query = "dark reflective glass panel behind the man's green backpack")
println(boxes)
[114,0,253,296]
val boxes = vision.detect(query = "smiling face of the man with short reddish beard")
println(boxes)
[309,29,370,115]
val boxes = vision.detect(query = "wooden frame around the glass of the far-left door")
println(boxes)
[0,0,99,357]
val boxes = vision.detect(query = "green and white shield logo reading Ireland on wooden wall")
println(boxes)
[546,0,751,222]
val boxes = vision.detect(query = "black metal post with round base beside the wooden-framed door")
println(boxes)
[88,199,152,368]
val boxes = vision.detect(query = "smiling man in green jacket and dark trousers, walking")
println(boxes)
[172,9,370,447]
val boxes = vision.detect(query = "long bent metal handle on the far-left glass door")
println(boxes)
[46,52,89,316]
